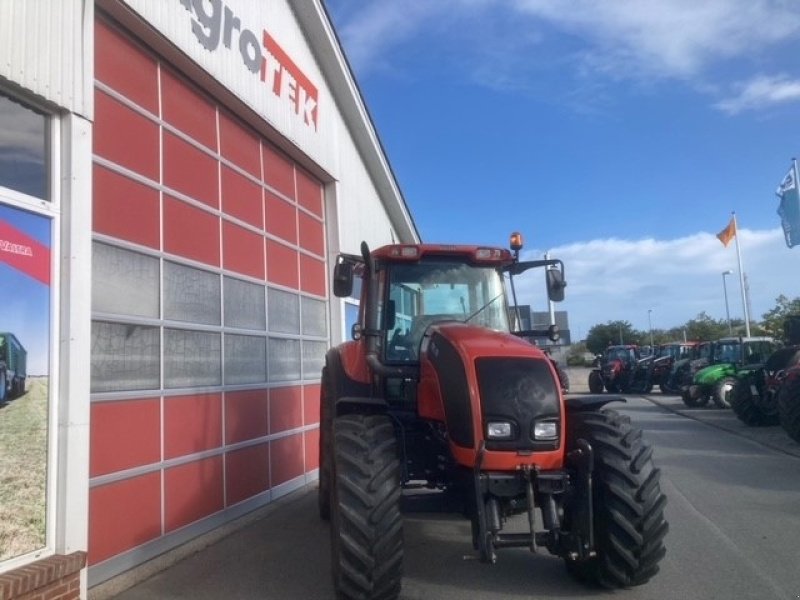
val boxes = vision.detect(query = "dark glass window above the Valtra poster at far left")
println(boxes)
[0,93,50,200]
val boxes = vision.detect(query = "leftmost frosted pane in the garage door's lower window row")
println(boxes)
[91,321,161,392]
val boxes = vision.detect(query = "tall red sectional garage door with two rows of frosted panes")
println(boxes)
[89,19,328,565]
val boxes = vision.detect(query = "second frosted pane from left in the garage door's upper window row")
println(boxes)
[164,262,220,325]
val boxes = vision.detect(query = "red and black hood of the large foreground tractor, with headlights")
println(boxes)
[418,321,564,462]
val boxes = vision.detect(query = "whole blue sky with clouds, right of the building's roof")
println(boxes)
[326,0,800,337]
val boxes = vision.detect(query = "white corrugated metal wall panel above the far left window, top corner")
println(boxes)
[0,0,94,119]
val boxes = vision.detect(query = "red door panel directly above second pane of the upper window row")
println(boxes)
[164,196,219,267]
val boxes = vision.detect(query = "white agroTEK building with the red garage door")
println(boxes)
[0,0,419,599]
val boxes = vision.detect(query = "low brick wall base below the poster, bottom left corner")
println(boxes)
[0,552,86,600]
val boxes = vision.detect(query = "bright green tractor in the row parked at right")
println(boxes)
[681,337,778,408]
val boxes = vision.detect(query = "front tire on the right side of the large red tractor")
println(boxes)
[565,409,669,588]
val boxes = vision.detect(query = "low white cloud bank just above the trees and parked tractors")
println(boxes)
[517,228,800,339]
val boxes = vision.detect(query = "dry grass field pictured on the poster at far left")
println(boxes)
[0,377,49,561]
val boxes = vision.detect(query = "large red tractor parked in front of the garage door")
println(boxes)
[319,234,668,599]
